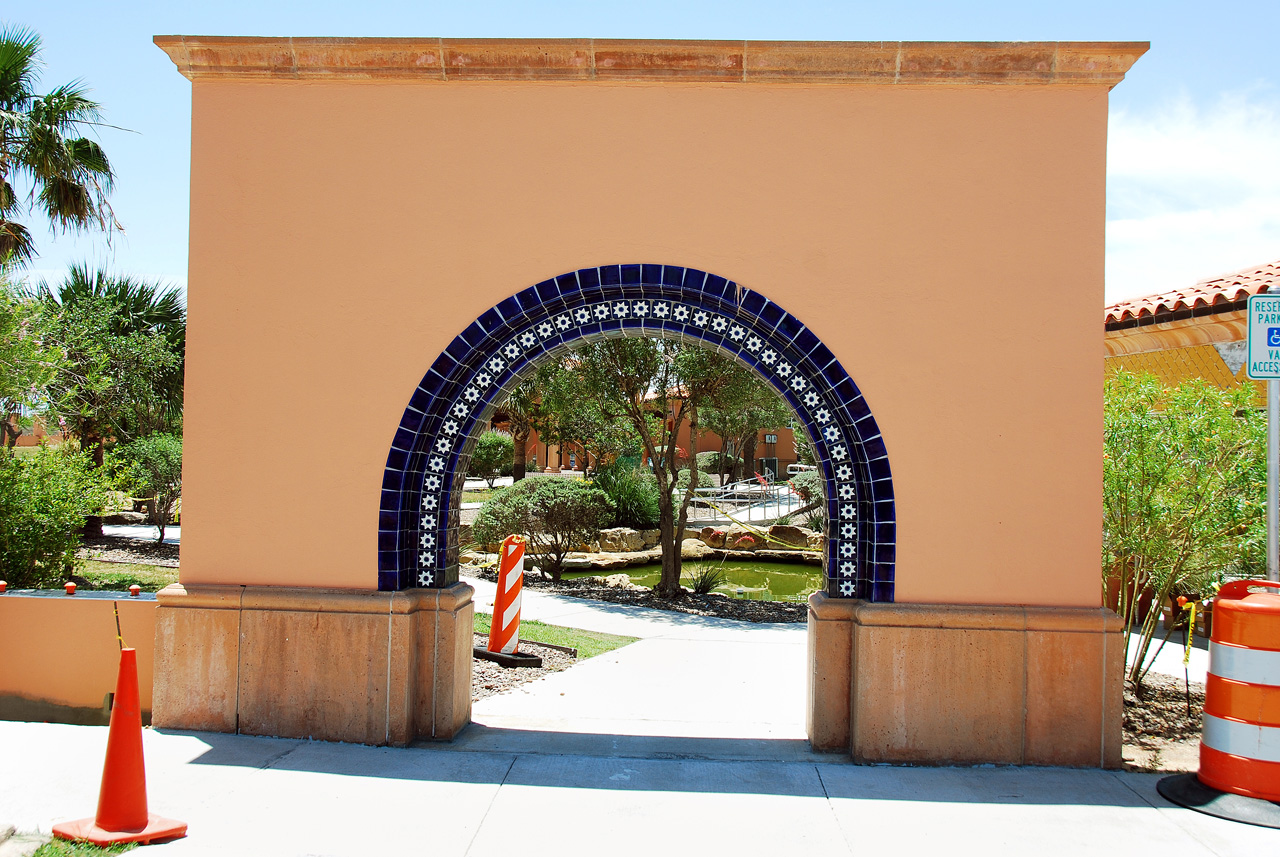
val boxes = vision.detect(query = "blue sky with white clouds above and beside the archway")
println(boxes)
[10,0,1280,302]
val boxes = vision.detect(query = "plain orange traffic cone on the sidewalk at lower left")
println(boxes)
[54,649,187,845]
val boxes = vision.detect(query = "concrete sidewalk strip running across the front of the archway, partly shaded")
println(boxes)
[0,723,1280,857]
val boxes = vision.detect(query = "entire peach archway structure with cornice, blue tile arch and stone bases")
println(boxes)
[154,36,1146,765]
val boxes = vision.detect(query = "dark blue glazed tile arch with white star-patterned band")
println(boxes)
[378,265,897,601]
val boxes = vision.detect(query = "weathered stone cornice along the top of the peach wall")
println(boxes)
[155,36,1149,87]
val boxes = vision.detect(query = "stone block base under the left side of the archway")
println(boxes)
[152,583,474,746]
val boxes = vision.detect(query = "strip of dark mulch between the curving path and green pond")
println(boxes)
[463,565,809,623]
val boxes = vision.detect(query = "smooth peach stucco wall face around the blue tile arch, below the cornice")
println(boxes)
[182,79,1107,606]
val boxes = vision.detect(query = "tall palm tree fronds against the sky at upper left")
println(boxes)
[0,27,120,261]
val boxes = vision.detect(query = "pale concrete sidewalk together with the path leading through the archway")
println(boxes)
[0,581,1280,857]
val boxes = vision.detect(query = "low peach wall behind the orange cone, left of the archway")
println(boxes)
[0,591,156,725]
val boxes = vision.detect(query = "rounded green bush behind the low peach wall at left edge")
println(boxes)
[0,446,109,588]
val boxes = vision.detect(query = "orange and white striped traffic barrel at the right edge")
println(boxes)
[1197,581,1280,801]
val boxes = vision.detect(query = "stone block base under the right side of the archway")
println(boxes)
[808,592,1124,767]
